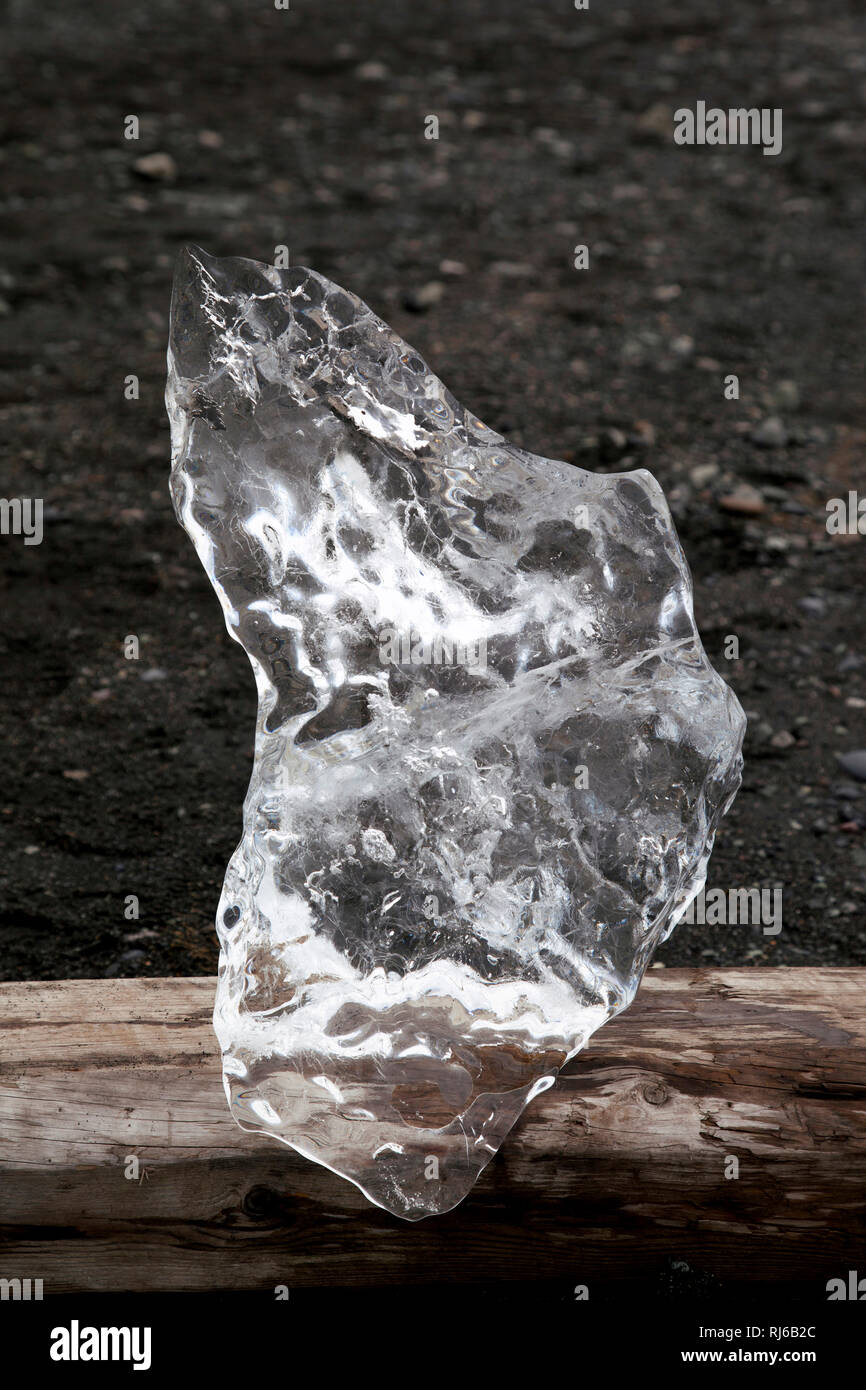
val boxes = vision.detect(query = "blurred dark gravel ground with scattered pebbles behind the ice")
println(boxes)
[0,0,866,979]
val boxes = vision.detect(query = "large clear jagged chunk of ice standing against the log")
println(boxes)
[167,249,744,1220]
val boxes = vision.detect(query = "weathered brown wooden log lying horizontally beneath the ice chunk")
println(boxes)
[0,969,866,1293]
